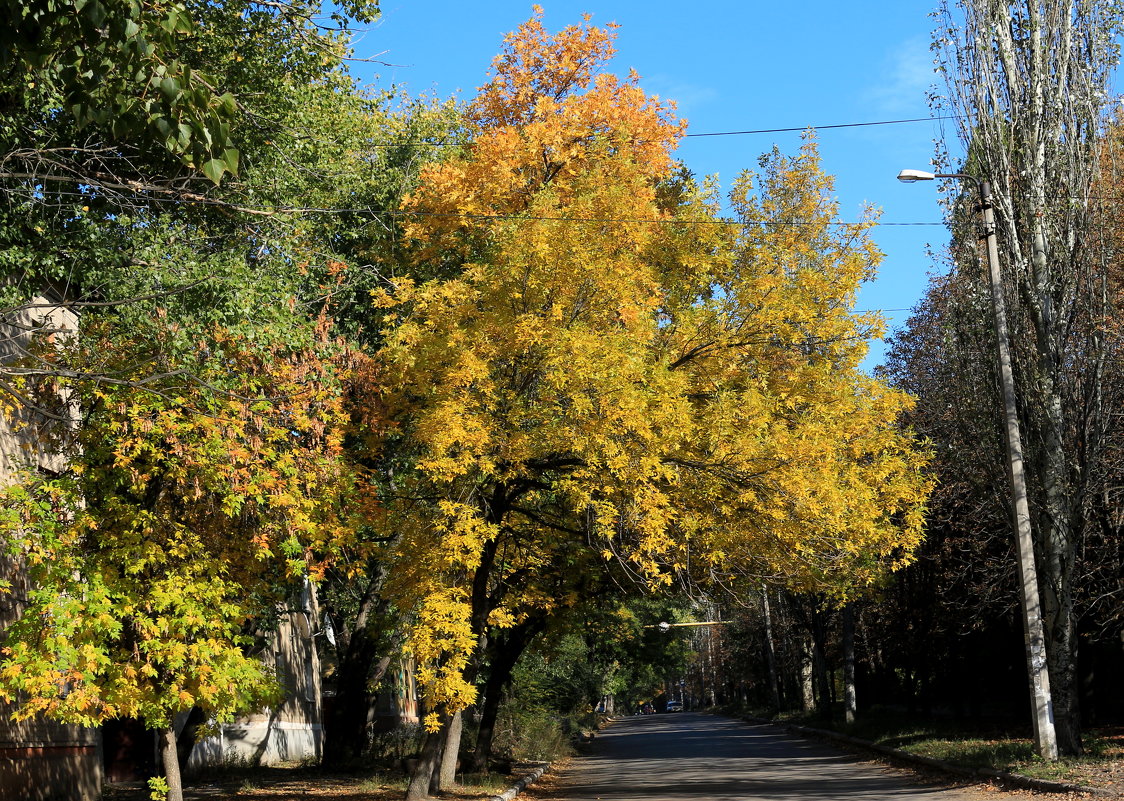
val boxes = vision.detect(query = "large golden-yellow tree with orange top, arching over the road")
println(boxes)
[368,7,927,795]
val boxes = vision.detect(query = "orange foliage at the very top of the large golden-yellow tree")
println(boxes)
[405,7,686,258]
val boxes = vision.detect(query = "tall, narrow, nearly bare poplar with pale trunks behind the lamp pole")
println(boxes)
[934,0,1121,754]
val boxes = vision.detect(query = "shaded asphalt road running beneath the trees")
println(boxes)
[551,712,994,801]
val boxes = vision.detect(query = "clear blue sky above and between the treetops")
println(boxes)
[343,0,955,367]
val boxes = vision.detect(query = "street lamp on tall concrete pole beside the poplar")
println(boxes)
[898,170,1058,762]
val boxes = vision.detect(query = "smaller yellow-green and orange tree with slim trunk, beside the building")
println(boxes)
[0,301,368,799]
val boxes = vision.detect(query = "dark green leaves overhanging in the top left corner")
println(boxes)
[0,0,374,183]
